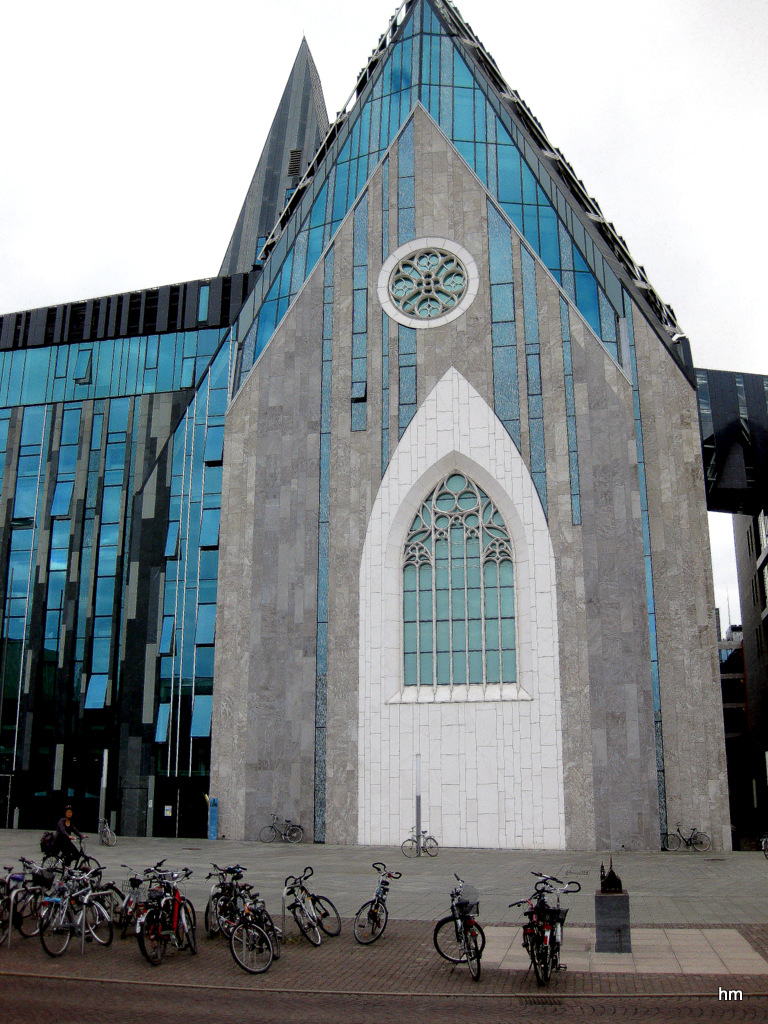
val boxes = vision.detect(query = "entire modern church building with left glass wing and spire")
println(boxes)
[0,0,730,849]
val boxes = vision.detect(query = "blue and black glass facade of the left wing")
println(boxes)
[0,309,230,830]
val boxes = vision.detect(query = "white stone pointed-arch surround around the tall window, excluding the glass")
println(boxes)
[358,368,565,849]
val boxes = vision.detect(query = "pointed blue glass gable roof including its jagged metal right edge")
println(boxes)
[236,0,693,389]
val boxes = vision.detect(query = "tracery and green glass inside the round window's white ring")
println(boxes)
[389,249,467,319]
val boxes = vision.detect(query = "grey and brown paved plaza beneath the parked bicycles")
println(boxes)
[0,831,768,1006]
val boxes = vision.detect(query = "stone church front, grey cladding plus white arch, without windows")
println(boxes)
[212,105,729,849]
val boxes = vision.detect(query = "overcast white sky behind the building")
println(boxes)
[0,0,768,622]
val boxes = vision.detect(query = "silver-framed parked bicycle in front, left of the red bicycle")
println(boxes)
[38,869,113,956]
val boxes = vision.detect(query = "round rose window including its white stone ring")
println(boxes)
[378,239,479,328]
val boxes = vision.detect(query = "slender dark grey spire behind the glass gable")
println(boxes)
[219,38,329,275]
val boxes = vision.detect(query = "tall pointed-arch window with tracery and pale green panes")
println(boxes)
[402,473,517,687]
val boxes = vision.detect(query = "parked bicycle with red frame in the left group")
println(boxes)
[136,858,198,967]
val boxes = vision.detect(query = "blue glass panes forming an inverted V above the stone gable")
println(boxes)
[234,0,622,397]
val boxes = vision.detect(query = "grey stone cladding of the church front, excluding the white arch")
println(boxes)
[211,106,730,850]
